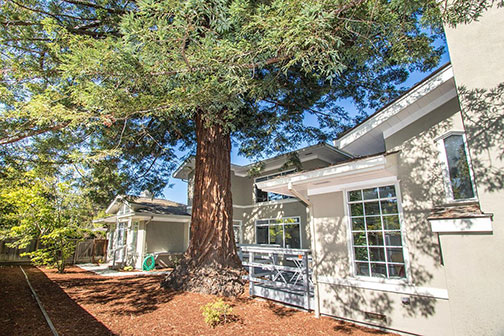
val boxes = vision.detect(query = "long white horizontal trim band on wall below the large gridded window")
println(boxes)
[318,276,448,300]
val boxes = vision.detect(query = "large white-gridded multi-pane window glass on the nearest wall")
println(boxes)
[348,185,406,279]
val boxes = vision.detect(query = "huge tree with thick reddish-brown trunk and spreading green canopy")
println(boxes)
[0,0,493,295]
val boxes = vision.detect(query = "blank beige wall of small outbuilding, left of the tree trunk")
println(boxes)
[146,222,188,253]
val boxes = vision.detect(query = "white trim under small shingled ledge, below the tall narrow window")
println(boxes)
[429,217,493,233]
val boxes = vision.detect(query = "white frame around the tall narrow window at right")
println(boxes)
[435,131,478,203]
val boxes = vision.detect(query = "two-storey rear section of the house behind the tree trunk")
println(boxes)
[173,143,353,248]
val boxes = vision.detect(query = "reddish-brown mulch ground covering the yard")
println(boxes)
[0,266,385,336]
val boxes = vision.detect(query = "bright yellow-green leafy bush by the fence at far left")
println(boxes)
[0,169,92,272]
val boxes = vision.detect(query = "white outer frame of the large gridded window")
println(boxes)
[342,179,412,285]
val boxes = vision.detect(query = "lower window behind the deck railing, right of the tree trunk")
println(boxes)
[256,217,301,248]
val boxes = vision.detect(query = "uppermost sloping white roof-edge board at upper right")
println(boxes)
[334,65,453,148]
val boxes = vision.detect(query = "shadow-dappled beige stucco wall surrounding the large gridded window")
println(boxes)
[310,99,470,335]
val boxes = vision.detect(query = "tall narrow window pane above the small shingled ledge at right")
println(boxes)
[442,134,475,200]
